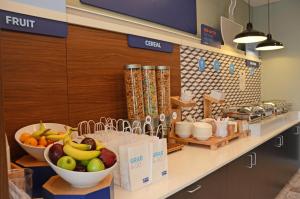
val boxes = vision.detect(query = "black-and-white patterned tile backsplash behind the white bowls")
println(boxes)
[180,46,261,119]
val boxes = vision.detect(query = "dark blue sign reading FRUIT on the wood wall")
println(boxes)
[0,10,68,37]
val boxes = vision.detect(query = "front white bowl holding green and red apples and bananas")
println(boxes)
[44,136,117,188]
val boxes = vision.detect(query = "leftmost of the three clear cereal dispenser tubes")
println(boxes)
[124,64,145,120]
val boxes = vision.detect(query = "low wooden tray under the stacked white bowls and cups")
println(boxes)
[169,131,250,150]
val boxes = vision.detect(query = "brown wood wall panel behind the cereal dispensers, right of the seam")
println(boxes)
[67,26,180,125]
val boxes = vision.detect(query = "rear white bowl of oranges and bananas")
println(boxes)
[15,122,70,161]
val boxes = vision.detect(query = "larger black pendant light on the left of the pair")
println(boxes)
[233,0,267,44]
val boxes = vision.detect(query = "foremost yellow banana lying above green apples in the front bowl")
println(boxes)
[63,144,100,160]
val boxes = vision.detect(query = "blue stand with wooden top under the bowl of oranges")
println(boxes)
[15,155,56,198]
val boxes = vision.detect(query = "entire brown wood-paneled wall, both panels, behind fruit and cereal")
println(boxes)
[0,25,181,158]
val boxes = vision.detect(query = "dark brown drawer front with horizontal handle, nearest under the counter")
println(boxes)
[169,167,228,199]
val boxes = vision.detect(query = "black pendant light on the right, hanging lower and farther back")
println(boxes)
[256,0,284,51]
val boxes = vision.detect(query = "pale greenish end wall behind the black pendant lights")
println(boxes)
[254,0,300,110]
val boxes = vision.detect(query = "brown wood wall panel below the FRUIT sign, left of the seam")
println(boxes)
[1,31,68,157]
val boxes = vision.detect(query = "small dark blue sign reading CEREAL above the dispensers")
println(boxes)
[128,35,173,53]
